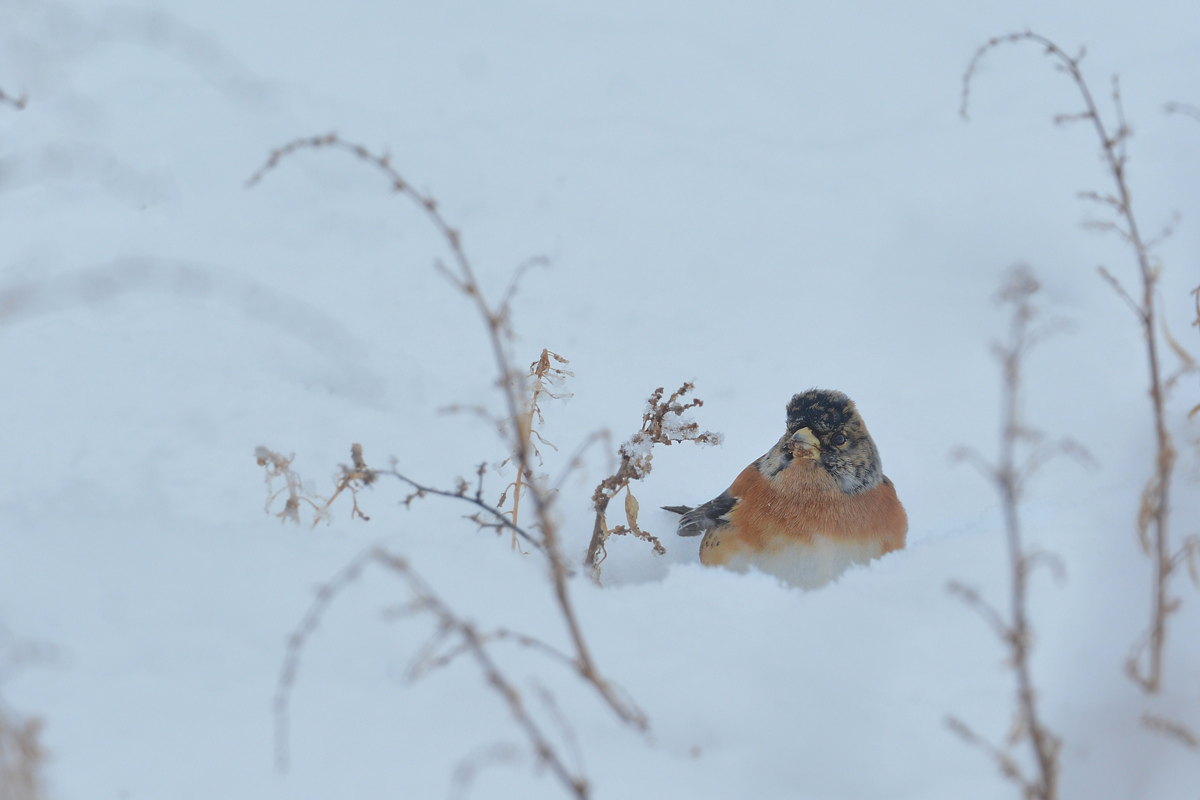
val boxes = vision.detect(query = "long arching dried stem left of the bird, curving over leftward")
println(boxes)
[247,133,647,730]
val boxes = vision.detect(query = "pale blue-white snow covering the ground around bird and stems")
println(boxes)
[0,0,1200,800]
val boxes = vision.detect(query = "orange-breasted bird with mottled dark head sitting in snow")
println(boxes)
[662,389,908,589]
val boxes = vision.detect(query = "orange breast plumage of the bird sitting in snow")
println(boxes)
[700,459,908,564]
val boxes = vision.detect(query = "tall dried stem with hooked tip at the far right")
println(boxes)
[961,31,1177,693]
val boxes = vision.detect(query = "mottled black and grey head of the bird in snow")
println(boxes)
[782,389,883,494]
